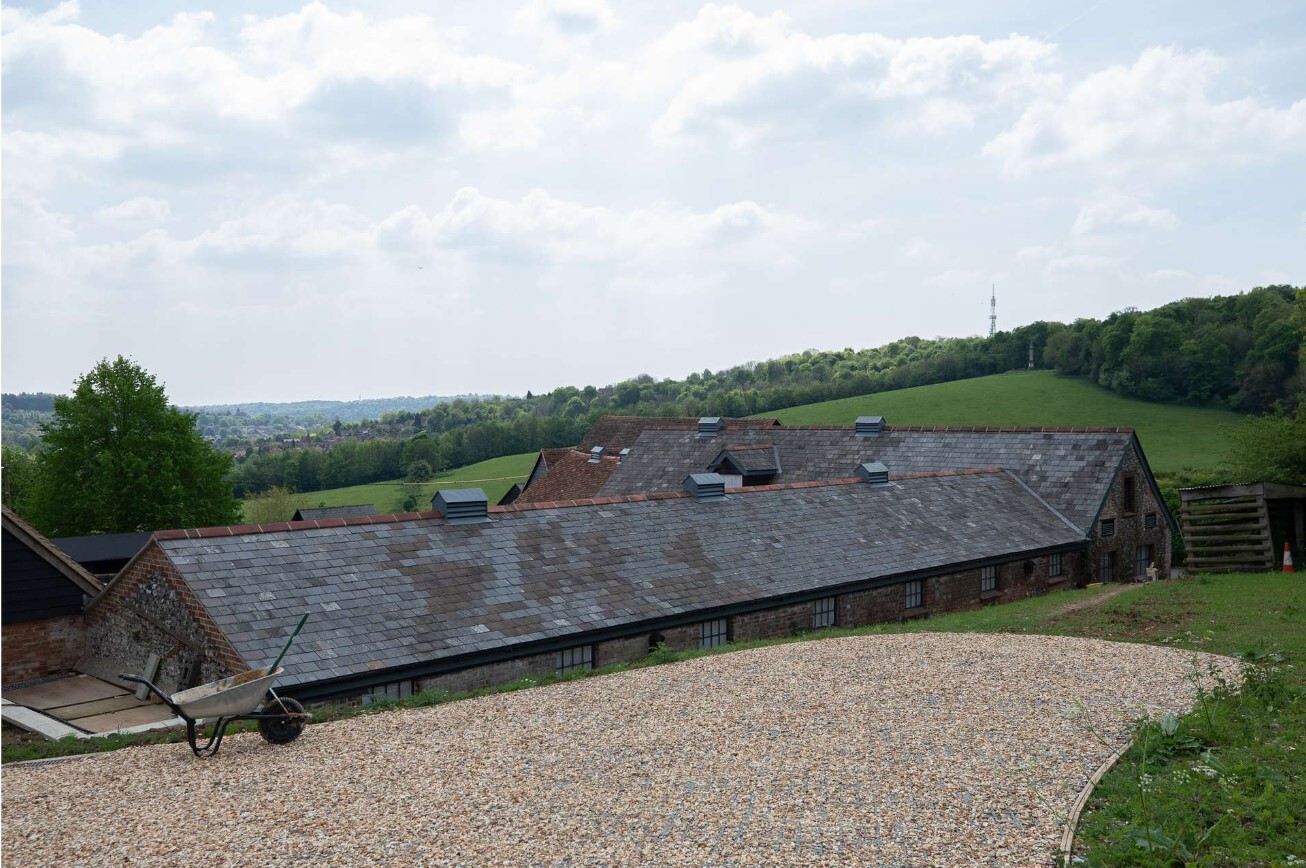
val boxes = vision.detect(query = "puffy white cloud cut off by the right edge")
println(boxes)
[985,48,1306,176]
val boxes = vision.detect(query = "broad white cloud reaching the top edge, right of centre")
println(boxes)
[650,4,1058,146]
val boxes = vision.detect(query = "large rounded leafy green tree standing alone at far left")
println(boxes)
[30,356,240,536]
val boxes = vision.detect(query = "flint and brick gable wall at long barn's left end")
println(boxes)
[77,543,248,693]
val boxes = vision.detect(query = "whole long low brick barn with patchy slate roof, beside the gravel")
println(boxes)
[80,466,1089,700]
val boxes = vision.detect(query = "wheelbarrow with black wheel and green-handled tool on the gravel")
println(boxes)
[118,615,308,757]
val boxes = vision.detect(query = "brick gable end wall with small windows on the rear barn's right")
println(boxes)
[1091,449,1170,582]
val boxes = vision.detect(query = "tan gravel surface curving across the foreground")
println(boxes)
[3,633,1237,867]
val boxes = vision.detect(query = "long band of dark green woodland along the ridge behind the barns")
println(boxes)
[224,286,1306,495]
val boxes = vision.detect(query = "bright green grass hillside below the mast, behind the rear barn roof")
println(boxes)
[761,371,1242,473]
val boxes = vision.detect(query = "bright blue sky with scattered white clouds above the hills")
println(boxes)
[0,0,1306,405]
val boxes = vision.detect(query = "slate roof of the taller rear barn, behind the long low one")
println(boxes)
[599,427,1134,530]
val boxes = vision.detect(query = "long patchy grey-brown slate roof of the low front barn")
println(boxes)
[155,470,1084,694]
